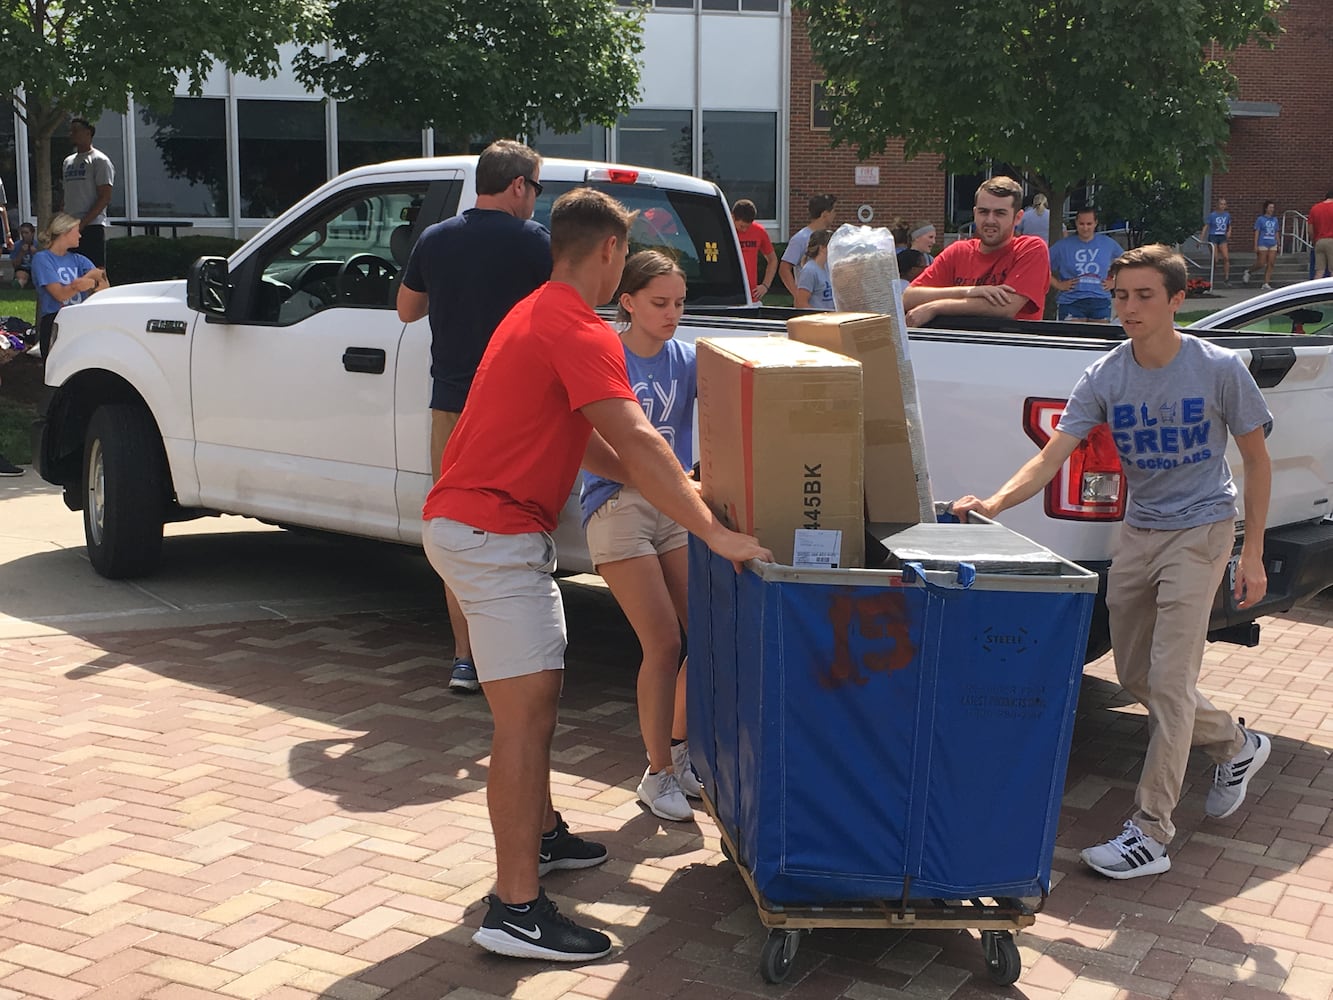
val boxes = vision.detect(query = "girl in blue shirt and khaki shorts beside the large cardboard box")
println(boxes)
[581,251,702,821]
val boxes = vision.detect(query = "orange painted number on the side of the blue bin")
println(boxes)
[820,591,916,688]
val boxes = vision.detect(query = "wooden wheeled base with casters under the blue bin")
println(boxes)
[704,791,1045,987]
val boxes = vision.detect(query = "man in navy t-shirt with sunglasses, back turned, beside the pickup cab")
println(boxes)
[397,139,551,691]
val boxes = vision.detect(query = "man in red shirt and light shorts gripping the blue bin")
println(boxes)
[423,188,773,961]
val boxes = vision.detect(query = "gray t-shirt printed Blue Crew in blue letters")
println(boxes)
[1056,333,1273,529]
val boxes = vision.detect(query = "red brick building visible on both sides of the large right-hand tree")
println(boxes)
[786,0,1333,239]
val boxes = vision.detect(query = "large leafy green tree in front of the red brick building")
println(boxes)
[794,0,1285,239]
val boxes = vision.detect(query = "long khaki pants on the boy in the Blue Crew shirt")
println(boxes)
[1106,520,1245,844]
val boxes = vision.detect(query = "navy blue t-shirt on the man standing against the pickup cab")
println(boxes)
[403,208,551,413]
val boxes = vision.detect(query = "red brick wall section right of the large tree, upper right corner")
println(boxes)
[1213,0,1333,225]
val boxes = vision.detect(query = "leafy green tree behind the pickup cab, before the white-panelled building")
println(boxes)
[296,0,643,149]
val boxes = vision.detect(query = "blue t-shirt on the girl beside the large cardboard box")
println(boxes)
[579,340,698,527]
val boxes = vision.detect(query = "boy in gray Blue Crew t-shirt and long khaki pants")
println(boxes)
[953,244,1273,879]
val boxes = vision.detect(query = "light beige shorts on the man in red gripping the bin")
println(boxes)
[421,517,565,684]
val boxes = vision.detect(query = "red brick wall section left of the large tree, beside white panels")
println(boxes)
[788,12,945,241]
